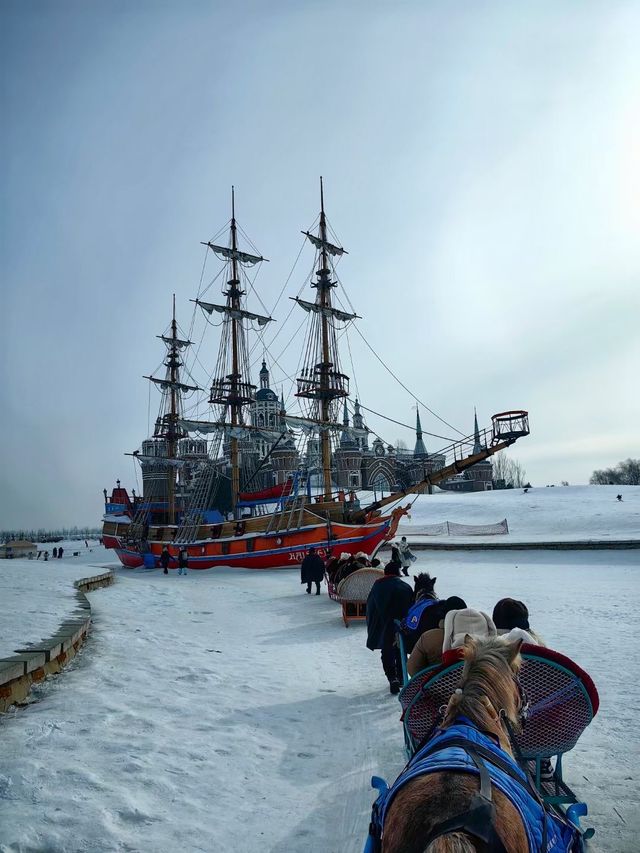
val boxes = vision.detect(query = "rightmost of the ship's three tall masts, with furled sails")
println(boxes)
[295,178,357,501]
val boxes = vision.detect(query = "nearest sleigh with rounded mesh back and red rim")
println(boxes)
[398,644,599,838]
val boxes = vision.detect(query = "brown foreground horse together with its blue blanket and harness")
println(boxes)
[378,635,582,853]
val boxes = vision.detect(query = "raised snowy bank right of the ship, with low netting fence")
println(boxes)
[399,486,640,544]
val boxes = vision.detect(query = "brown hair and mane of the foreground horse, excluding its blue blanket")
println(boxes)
[382,635,529,853]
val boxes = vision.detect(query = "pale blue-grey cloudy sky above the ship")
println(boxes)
[0,0,640,529]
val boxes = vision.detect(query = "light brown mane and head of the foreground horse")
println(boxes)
[442,634,522,752]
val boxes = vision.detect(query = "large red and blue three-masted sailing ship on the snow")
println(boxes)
[103,178,529,569]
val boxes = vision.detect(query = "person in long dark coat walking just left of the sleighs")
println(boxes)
[367,560,413,693]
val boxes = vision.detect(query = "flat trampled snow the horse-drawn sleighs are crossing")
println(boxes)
[0,489,640,853]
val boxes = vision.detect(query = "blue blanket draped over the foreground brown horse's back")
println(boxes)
[365,719,583,853]
